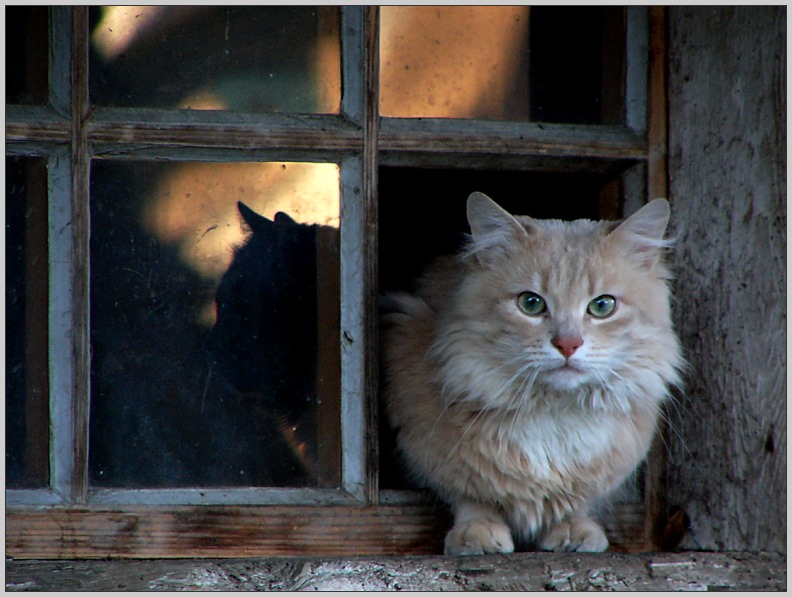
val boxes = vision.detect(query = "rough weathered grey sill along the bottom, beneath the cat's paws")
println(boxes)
[6,552,786,591]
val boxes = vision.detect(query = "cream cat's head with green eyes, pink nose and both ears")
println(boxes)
[442,193,677,407]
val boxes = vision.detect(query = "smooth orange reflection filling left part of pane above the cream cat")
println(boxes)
[380,6,530,119]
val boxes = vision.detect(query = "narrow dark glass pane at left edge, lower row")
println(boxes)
[5,158,49,488]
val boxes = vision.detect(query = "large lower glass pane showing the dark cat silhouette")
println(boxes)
[89,161,340,488]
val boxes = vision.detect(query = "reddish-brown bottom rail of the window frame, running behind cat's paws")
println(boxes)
[6,500,656,559]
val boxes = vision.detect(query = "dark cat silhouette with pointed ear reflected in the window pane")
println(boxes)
[206,202,324,478]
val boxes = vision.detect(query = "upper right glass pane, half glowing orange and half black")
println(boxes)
[380,6,624,124]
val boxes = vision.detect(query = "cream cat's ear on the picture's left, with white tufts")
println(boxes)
[467,192,528,263]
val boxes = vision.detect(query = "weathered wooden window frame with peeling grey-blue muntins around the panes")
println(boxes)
[6,6,667,558]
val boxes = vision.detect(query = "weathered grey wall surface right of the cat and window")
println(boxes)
[668,6,787,552]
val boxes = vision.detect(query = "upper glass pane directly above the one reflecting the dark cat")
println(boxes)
[90,6,341,113]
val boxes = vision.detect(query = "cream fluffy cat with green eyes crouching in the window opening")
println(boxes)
[383,193,682,554]
